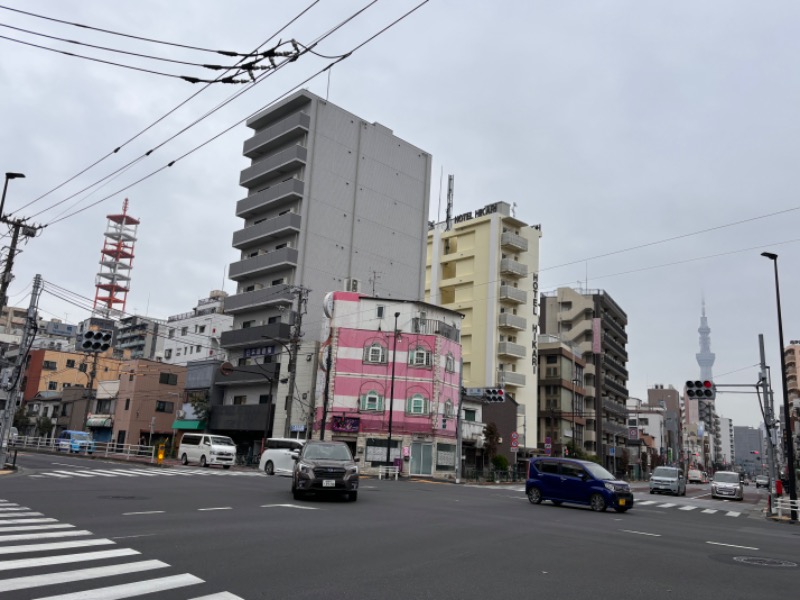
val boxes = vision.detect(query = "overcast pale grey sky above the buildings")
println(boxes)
[0,0,800,426]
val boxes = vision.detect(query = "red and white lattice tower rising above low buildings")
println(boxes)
[94,198,139,318]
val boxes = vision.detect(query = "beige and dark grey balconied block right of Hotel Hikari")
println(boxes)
[539,288,628,470]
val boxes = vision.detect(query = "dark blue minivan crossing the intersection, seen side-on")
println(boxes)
[525,456,633,512]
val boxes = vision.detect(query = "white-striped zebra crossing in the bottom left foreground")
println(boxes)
[0,500,242,600]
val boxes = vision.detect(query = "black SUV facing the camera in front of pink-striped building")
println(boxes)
[292,440,358,502]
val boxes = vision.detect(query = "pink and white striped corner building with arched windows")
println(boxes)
[314,292,462,477]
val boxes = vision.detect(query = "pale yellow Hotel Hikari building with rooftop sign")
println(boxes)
[425,202,542,448]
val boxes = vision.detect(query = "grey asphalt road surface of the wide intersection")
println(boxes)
[0,453,800,600]
